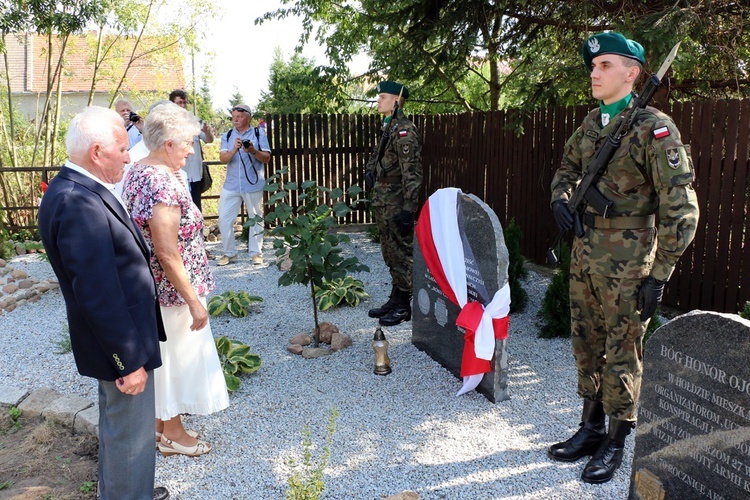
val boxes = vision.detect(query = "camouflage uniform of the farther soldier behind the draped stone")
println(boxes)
[367,109,422,294]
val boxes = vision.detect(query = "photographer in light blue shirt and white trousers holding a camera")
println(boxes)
[216,104,271,266]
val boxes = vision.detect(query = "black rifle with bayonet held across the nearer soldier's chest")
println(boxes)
[547,42,681,266]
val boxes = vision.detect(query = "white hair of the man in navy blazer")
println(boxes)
[65,106,125,156]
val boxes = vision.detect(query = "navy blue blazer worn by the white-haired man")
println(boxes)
[38,167,166,381]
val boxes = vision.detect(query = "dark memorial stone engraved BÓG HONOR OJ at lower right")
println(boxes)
[630,311,750,500]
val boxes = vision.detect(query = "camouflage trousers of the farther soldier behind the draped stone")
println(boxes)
[373,206,414,294]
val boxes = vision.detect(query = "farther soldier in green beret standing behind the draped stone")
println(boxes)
[365,81,422,326]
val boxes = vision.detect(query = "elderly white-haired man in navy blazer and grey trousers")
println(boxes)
[39,107,168,500]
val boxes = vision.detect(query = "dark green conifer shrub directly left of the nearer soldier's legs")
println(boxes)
[538,242,570,339]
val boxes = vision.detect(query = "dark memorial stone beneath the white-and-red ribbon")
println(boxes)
[412,194,510,403]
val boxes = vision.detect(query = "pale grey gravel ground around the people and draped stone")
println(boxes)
[0,234,633,500]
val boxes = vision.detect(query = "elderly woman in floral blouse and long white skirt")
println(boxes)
[123,103,229,456]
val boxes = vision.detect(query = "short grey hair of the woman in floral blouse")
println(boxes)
[143,101,200,151]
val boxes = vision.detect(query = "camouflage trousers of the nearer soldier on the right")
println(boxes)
[570,262,648,421]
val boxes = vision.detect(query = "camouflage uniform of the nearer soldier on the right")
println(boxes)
[552,102,698,421]
